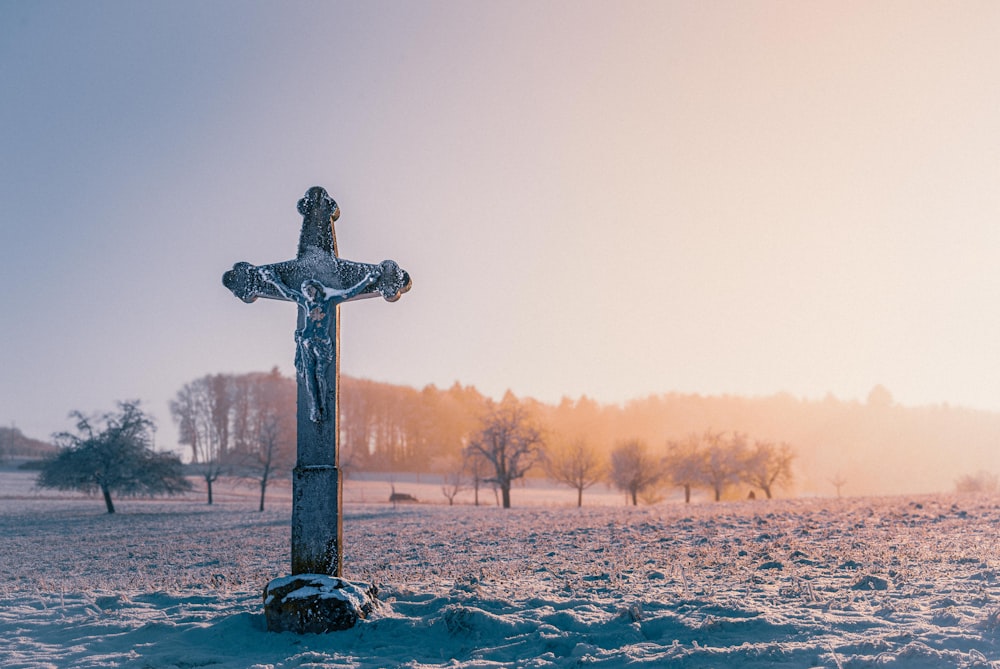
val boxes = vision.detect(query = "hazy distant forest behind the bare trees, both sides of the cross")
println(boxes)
[171,370,1000,496]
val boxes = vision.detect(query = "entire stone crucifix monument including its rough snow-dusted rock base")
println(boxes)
[222,186,411,634]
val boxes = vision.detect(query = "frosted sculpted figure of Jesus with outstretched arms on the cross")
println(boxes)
[257,267,382,423]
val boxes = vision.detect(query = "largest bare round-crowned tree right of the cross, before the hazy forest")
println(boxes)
[466,391,544,509]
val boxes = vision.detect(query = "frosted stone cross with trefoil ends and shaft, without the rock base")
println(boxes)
[222,186,410,577]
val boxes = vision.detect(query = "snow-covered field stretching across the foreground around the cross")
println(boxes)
[0,472,1000,669]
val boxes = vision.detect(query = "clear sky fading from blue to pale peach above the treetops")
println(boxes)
[0,0,1000,446]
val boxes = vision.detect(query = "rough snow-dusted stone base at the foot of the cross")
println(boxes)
[264,574,378,634]
